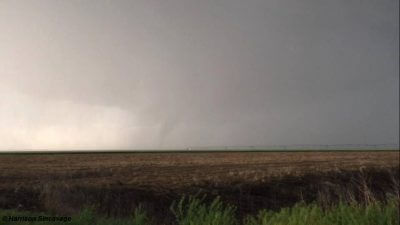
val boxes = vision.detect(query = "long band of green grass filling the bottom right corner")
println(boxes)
[244,200,399,225]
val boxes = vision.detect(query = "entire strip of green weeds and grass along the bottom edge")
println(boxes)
[0,196,400,225]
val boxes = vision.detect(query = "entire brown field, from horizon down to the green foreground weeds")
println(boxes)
[0,151,400,221]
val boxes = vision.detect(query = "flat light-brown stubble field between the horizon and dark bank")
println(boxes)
[0,151,399,190]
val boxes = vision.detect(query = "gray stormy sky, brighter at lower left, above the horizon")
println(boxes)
[0,0,399,149]
